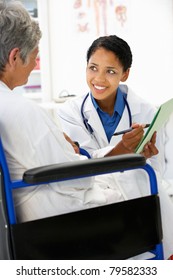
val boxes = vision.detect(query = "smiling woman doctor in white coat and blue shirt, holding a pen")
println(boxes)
[58,35,173,257]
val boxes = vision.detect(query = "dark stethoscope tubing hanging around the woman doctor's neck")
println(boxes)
[81,93,132,134]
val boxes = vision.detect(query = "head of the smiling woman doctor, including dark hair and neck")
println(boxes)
[86,35,132,113]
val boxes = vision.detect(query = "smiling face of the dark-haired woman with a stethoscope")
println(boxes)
[86,48,129,104]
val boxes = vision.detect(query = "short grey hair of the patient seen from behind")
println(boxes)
[0,0,41,73]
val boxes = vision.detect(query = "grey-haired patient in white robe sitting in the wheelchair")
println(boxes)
[0,0,173,257]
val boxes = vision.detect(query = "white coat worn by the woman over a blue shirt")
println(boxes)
[57,85,164,173]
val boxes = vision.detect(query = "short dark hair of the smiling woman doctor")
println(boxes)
[86,35,132,71]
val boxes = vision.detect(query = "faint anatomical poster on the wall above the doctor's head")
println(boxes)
[73,0,130,37]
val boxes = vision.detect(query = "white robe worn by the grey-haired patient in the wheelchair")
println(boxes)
[0,82,173,258]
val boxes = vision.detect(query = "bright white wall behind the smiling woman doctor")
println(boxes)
[40,0,173,105]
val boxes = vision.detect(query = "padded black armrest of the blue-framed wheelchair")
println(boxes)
[23,154,146,184]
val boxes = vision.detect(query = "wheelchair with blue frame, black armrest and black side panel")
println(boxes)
[0,138,164,260]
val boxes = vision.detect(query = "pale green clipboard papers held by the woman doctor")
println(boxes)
[135,98,173,153]
